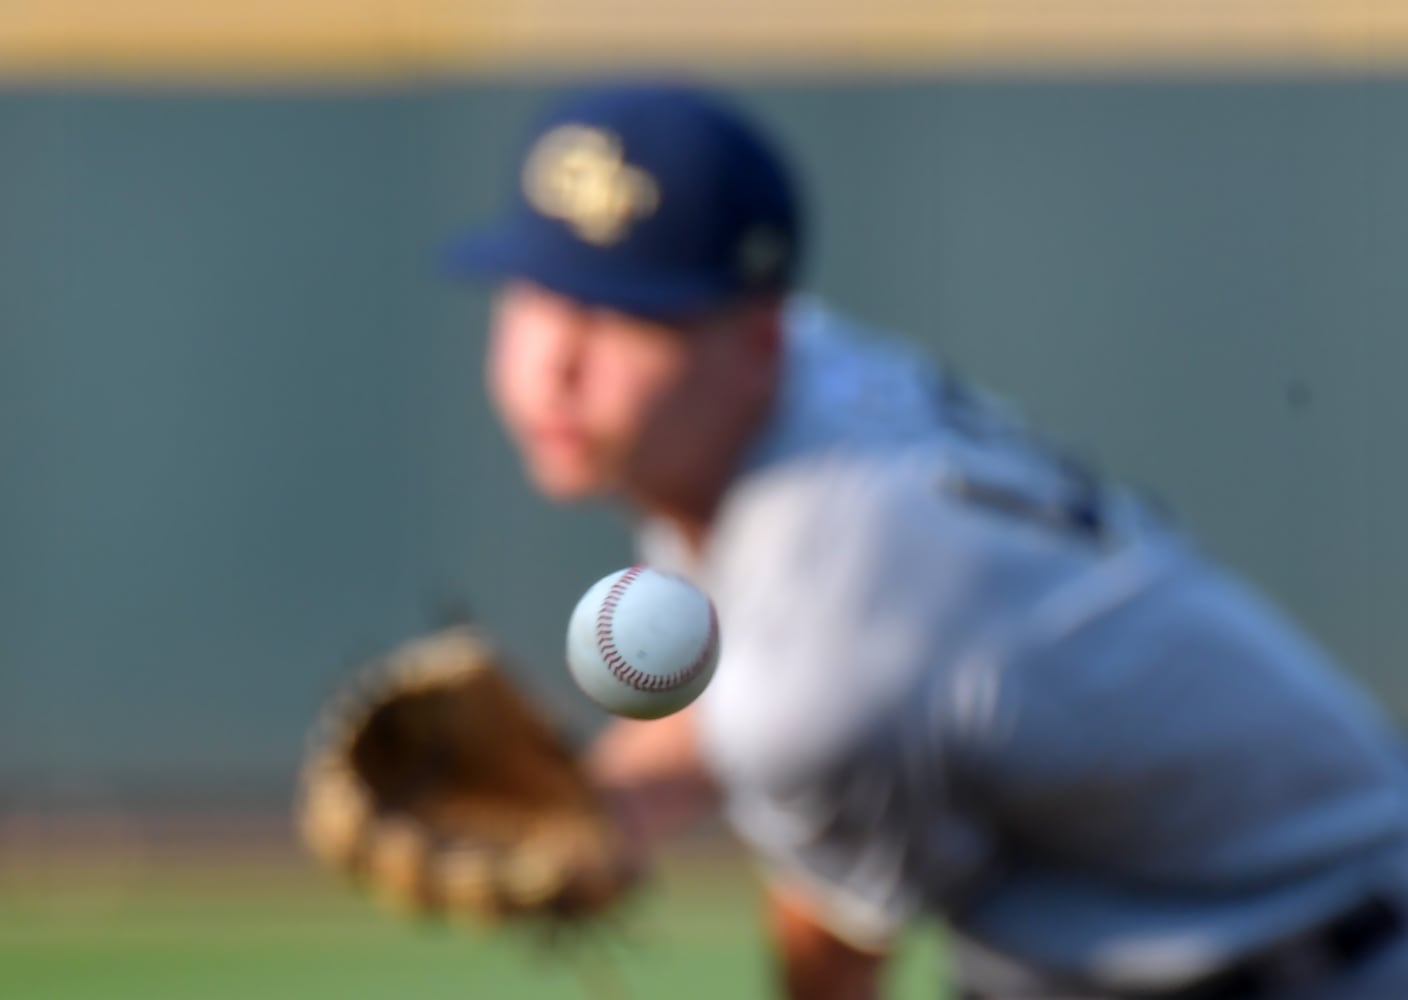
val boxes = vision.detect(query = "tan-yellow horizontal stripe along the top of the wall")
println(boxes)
[0,0,1408,80]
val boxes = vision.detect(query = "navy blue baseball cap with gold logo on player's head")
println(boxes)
[449,83,803,320]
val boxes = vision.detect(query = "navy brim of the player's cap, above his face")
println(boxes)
[445,221,734,320]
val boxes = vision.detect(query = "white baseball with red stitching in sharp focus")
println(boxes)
[567,566,718,718]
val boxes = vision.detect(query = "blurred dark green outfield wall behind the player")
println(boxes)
[0,77,1408,810]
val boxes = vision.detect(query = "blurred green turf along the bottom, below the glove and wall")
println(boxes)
[0,861,943,1000]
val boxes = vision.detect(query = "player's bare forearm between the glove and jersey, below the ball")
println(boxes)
[587,708,719,845]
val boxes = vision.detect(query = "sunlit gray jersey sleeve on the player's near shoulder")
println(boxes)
[700,455,1036,944]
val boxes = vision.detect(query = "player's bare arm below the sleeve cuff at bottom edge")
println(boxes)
[769,887,886,1000]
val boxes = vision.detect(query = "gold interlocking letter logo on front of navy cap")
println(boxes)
[522,125,660,246]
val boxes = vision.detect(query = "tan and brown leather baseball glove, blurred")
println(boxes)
[297,628,636,923]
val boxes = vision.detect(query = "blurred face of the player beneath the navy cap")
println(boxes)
[487,283,758,503]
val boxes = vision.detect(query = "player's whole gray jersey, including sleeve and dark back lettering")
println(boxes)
[641,301,1408,996]
